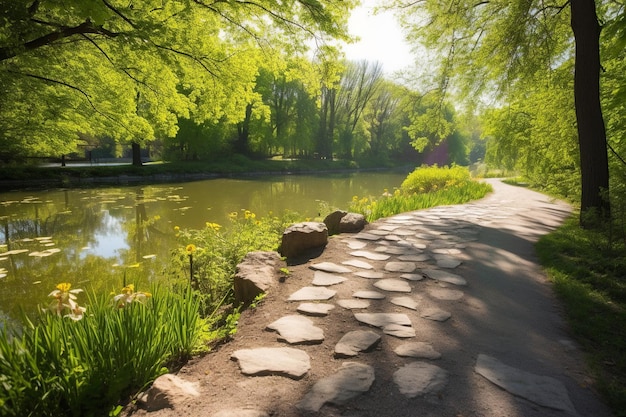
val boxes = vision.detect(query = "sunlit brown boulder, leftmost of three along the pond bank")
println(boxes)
[234,251,287,306]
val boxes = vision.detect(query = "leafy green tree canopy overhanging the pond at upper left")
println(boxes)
[0,0,354,165]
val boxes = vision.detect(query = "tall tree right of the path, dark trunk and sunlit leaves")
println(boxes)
[394,0,621,224]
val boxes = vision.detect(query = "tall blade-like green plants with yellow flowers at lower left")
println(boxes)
[0,287,204,416]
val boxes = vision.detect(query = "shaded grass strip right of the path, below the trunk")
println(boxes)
[536,216,626,416]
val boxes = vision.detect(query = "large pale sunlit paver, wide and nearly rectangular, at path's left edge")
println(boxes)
[231,347,311,379]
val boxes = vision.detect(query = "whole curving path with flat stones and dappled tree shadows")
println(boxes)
[133,182,610,417]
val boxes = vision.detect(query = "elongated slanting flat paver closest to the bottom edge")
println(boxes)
[296,362,375,412]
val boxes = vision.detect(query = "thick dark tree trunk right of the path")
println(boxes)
[568,0,610,226]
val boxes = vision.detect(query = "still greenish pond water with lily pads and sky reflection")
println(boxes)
[0,172,407,322]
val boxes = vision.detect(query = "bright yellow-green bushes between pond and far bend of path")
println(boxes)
[350,167,492,222]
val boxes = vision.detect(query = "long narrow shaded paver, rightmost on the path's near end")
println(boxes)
[474,354,577,415]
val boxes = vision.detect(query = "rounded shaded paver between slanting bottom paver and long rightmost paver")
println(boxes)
[393,362,448,398]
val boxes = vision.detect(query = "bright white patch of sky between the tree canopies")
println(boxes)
[344,0,413,74]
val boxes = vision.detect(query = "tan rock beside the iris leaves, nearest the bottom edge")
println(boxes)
[140,374,200,411]
